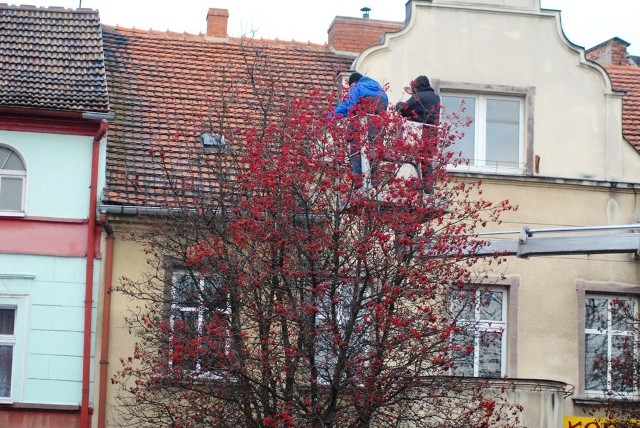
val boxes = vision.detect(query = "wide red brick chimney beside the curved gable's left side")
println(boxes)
[328,16,404,53]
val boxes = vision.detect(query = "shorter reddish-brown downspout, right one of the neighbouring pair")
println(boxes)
[98,214,115,428]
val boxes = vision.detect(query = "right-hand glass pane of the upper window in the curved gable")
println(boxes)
[486,99,520,168]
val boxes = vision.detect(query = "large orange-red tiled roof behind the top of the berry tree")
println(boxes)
[102,26,353,206]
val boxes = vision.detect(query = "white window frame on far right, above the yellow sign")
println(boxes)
[583,293,638,396]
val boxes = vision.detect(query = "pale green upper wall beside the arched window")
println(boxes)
[0,131,93,218]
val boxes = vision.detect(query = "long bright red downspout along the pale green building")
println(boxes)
[80,120,107,428]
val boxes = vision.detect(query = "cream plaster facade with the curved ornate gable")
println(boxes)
[353,0,640,427]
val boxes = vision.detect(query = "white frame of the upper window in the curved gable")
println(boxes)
[433,79,535,175]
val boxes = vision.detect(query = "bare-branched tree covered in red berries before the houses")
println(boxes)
[113,44,519,427]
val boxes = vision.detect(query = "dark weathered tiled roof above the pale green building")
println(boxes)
[0,4,109,112]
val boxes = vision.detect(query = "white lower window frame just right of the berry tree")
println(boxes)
[452,285,509,377]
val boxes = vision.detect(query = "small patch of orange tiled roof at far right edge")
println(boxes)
[605,65,640,151]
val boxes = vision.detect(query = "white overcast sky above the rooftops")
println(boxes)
[11,0,640,55]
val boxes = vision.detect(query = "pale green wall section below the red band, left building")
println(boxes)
[0,254,100,405]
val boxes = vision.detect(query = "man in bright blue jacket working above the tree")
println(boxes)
[329,72,389,184]
